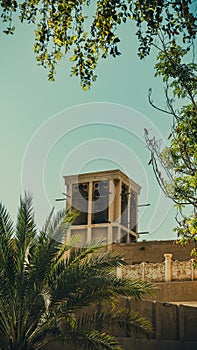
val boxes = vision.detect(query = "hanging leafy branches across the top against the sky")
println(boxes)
[1,0,197,90]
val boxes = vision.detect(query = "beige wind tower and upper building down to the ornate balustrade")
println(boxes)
[64,170,197,288]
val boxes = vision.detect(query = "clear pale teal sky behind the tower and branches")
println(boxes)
[0,17,176,239]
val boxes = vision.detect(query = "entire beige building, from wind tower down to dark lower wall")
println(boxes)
[50,170,197,350]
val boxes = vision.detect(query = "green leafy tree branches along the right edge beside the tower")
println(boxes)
[145,38,197,260]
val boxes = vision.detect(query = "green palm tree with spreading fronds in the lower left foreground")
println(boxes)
[0,194,153,350]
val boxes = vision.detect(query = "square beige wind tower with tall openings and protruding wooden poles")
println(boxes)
[64,170,141,244]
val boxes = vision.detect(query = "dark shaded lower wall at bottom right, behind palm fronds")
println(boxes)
[45,298,197,350]
